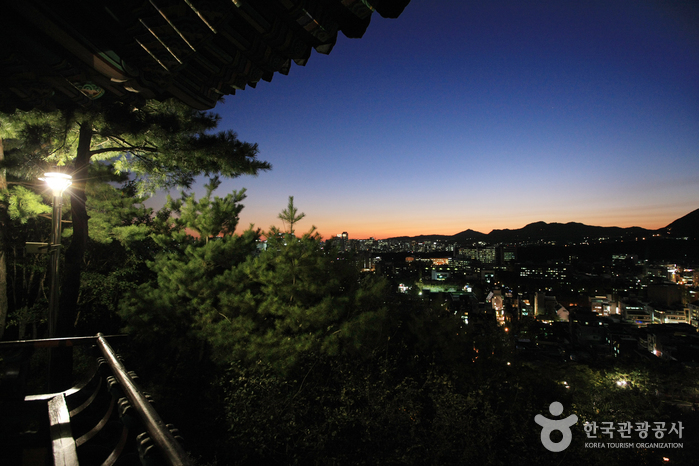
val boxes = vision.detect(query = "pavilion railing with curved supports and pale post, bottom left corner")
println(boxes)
[0,333,192,466]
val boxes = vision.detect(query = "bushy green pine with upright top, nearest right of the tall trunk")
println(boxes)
[119,183,260,378]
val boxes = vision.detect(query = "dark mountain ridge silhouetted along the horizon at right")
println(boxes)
[389,209,699,243]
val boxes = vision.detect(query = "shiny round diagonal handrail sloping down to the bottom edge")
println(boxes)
[97,333,193,466]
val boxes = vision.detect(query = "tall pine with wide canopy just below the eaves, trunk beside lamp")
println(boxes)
[0,101,270,342]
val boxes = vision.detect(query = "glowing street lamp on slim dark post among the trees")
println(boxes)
[39,172,73,338]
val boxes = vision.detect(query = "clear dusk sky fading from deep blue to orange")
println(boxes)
[156,0,699,239]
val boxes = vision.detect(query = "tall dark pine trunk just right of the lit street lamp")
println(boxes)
[49,121,92,391]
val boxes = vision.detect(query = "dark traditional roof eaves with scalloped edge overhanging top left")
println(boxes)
[0,0,410,112]
